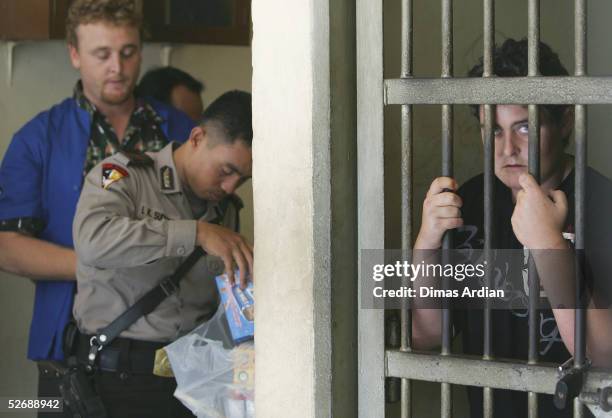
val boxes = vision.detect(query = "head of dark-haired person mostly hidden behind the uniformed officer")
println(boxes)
[136,67,204,122]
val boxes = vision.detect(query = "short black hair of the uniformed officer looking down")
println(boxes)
[202,90,253,147]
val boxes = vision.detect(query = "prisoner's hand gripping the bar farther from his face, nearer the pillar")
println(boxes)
[414,177,463,250]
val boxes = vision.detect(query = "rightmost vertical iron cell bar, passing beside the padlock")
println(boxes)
[574,0,587,418]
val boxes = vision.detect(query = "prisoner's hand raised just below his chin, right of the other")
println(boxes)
[512,174,567,250]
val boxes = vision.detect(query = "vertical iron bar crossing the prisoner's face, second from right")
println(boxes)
[527,0,540,418]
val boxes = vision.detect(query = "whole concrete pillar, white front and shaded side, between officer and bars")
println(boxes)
[252,0,357,418]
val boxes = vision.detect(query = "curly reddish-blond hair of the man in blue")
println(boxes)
[66,0,142,47]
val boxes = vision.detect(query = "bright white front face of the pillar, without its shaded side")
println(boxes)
[252,0,318,418]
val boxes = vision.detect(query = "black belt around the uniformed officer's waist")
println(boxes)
[76,334,168,374]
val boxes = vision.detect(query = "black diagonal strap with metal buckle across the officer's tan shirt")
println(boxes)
[87,247,204,367]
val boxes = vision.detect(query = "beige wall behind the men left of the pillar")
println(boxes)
[0,41,253,404]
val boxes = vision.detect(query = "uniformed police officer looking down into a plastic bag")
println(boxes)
[73,91,253,417]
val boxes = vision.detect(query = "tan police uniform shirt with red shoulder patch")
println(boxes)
[73,143,238,341]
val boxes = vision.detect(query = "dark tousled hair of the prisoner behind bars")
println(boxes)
[468,39,569,125]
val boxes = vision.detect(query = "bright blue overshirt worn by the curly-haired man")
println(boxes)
[0,99,194,360]
